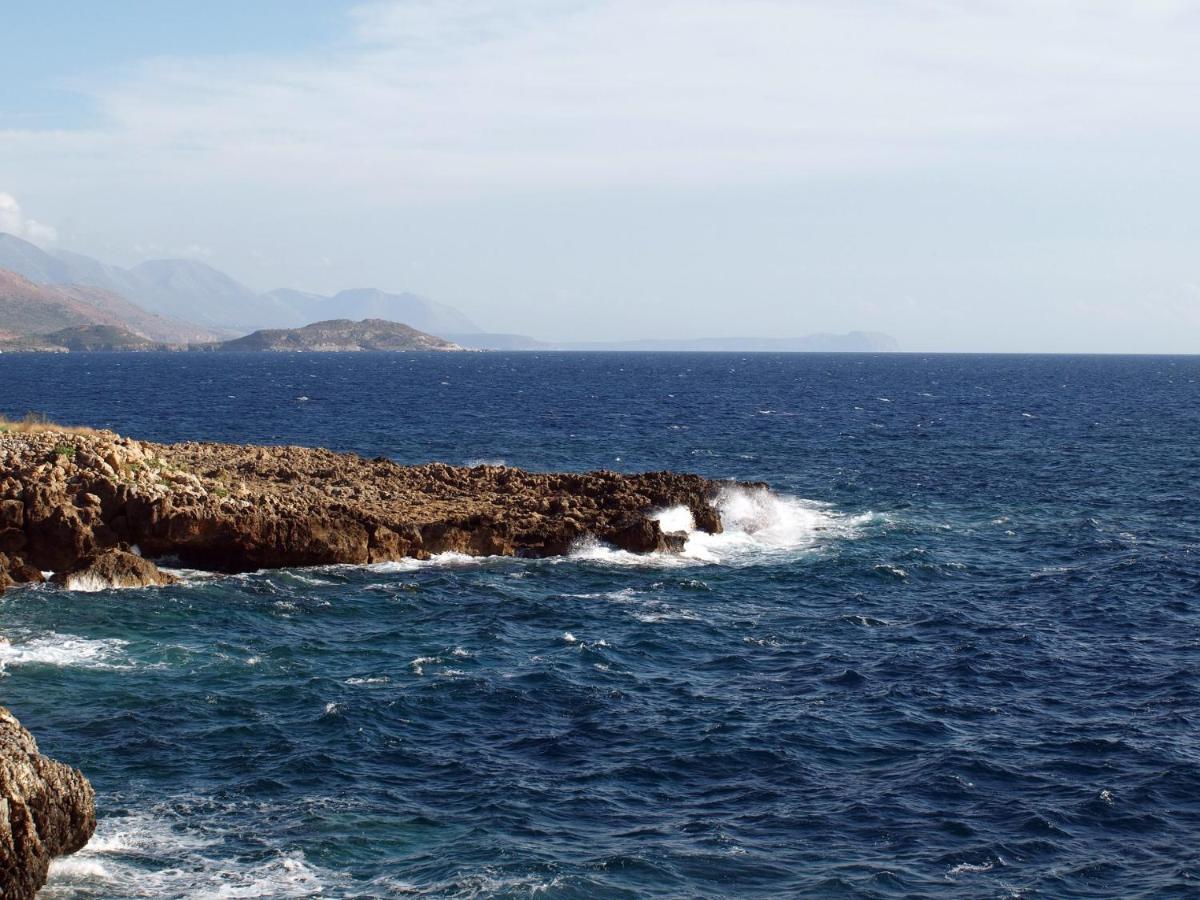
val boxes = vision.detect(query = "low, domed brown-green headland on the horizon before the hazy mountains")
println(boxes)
[211,319,462,353]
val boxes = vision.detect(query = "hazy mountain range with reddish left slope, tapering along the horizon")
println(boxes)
[0,233,899,353]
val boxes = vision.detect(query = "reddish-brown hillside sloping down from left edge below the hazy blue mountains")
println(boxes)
[0,269,211,342]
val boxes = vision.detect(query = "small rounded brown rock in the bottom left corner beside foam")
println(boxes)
[0,707,96,900]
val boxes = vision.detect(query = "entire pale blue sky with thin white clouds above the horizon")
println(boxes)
[0,0,1200,353]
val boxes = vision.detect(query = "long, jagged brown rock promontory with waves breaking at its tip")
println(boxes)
[0,431,721,592]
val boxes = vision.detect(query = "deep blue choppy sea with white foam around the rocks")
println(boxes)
[0,353,1200,900]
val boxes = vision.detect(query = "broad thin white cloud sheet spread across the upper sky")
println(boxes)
[9,0,1200,197]
